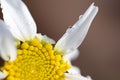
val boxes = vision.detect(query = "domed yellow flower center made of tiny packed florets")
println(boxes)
[1,38,70,80]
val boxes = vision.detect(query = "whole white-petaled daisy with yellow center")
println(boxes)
[0,0,98,80]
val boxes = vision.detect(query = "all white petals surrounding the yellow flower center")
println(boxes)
[0,0,98,80]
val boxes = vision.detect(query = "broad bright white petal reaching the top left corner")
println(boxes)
[1,0,36,41]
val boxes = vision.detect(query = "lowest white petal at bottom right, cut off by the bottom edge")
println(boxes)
[65,73,92,80]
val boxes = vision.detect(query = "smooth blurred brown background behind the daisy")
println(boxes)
[1,0,120,80]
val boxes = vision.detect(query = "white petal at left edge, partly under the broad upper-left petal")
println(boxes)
[0,20,17,61]
